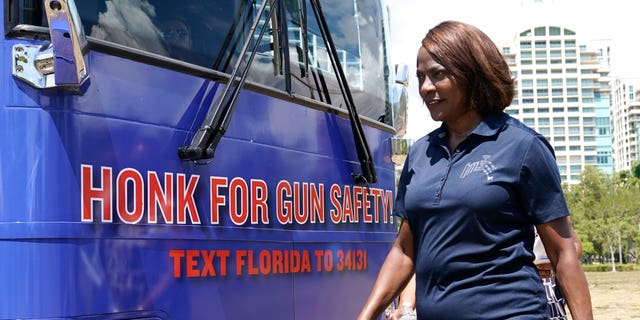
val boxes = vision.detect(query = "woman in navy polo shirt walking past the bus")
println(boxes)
[358,21,593,320]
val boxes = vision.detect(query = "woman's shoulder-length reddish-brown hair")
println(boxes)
[422,21,514,116]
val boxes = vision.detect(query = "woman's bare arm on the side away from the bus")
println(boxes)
[536,217,593,320]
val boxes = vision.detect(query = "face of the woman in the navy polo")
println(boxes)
[416,47,467,122]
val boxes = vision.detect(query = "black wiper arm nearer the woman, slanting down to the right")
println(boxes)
[310,0,378,183]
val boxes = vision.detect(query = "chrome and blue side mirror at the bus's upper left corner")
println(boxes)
[12,0,88,88]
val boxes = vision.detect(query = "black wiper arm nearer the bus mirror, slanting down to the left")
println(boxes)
[178,0,280,161]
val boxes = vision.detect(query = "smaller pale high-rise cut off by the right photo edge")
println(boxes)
[611,78,640,172]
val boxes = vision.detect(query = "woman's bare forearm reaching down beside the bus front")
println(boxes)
[357,220,414,320]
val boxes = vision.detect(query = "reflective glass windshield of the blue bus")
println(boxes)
[42,0,391,123]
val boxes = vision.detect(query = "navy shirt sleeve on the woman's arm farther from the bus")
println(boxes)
[518,135,569,224]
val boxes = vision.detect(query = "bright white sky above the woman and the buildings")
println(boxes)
[386,0,640,139]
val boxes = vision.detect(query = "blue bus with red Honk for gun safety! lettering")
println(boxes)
[0,0,406,319]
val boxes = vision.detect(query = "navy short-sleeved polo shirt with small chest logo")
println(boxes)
[395,113,569,320]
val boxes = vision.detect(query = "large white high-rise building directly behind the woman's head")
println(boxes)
[502,25,613,184]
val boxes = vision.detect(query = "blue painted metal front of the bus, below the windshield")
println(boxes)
[0,10,395,319]
